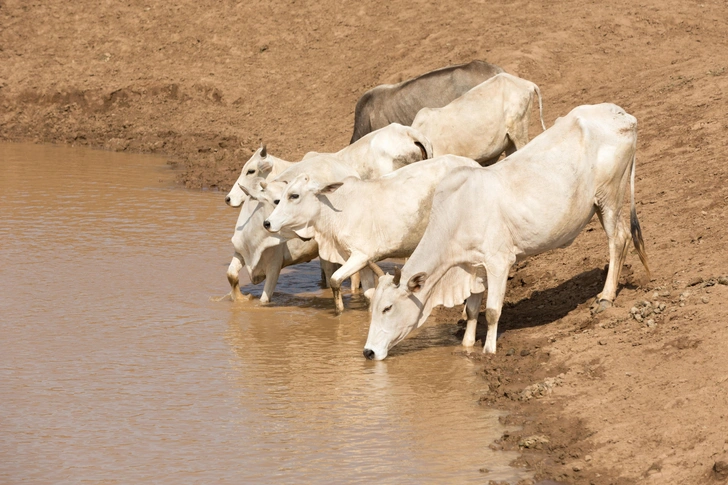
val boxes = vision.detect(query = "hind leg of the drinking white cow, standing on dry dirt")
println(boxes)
[596,208,630,313]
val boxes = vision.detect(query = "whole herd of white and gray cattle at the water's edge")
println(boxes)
[220,61,649,360]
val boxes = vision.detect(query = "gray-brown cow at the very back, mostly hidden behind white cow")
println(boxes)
[349,60,503,143]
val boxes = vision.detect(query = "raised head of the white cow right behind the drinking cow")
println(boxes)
[263,174,342,239]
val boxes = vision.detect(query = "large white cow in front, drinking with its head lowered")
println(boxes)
[364,104,650,359]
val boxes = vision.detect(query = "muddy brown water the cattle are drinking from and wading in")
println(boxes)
[0,145,522,484]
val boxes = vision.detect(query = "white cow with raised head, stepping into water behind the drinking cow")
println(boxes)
[263,155,478,312]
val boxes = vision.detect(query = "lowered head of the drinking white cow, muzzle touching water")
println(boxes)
[364,268,427,360]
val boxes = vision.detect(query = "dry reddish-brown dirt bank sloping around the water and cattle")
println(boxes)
[0,0,728,484]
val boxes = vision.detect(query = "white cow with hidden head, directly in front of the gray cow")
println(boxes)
[412,73,546,165]
